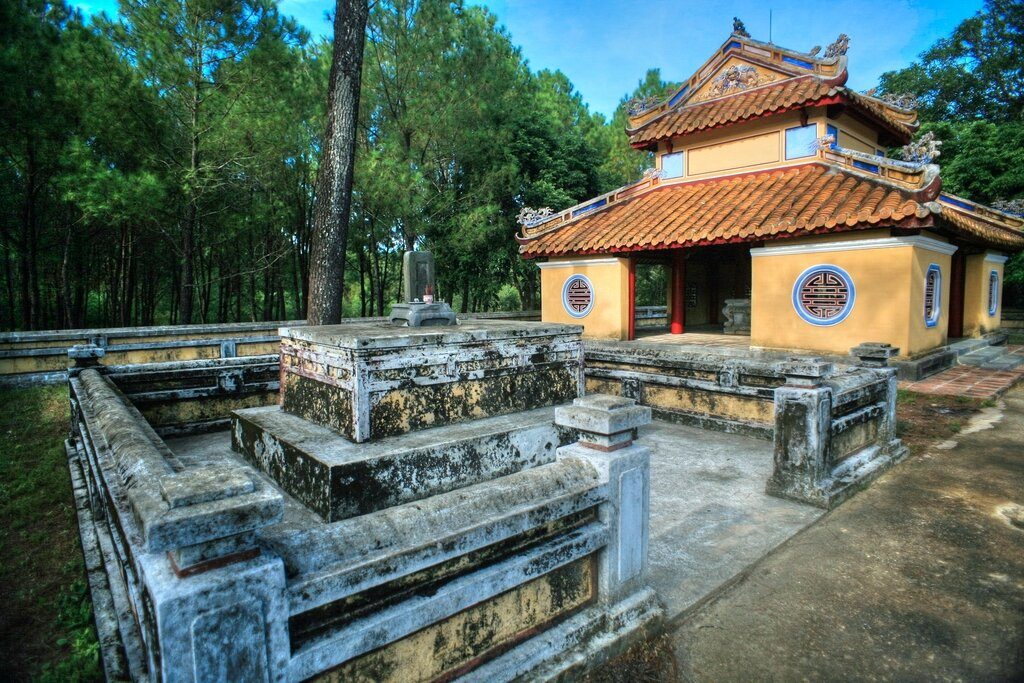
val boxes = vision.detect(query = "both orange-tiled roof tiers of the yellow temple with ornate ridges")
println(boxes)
[518,28,1024,258]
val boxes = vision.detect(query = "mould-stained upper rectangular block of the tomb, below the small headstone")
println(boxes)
[281,321,583,442]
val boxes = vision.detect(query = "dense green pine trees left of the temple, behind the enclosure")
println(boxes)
[0,0,696,329]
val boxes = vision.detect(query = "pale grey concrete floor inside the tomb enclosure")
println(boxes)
[167,420,823,618]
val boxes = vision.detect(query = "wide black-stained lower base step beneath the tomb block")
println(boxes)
[231,405,574,522]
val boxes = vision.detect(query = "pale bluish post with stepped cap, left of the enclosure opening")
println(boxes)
[555,394,650,604]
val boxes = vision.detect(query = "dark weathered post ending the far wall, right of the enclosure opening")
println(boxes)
[766,357,833,506]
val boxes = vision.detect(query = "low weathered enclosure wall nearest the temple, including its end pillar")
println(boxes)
[585,342,905,507]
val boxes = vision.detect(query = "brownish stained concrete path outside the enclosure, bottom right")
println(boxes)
[671,387,1024,681]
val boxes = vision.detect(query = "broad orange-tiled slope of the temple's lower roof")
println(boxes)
[520,162,938,257]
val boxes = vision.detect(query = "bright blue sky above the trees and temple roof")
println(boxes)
[73,0,982,116]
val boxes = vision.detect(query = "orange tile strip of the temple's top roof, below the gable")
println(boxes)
[627,76,913,147]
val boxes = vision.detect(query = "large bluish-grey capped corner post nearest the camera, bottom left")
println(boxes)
[136,465,290,683]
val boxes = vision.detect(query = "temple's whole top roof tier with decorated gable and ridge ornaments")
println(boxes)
[626,33,918,148]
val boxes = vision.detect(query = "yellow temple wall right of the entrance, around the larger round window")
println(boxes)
[751,231,951,356]
